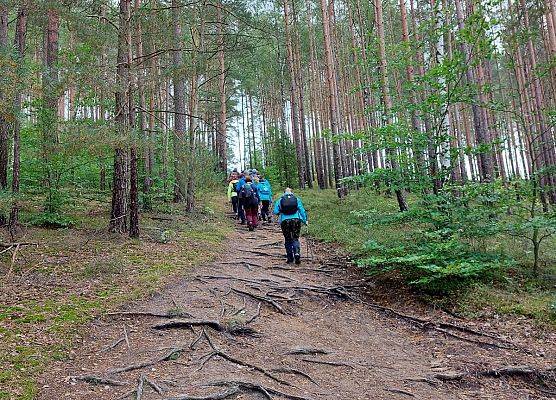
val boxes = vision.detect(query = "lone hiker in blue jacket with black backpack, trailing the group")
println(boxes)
[274,188,308,264]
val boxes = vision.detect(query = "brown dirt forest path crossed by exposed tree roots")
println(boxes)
[38,214,555,400]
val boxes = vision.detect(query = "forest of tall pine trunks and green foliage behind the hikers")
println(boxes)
[0,0,556,266]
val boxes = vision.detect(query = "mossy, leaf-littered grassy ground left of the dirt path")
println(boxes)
[0,192,231,400]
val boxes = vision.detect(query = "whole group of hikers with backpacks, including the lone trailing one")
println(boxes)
[228,169,308,264]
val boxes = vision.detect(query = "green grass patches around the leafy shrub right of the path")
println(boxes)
[299,188,556,327]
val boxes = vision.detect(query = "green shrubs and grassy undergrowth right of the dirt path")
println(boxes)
[300,188,556,321]
